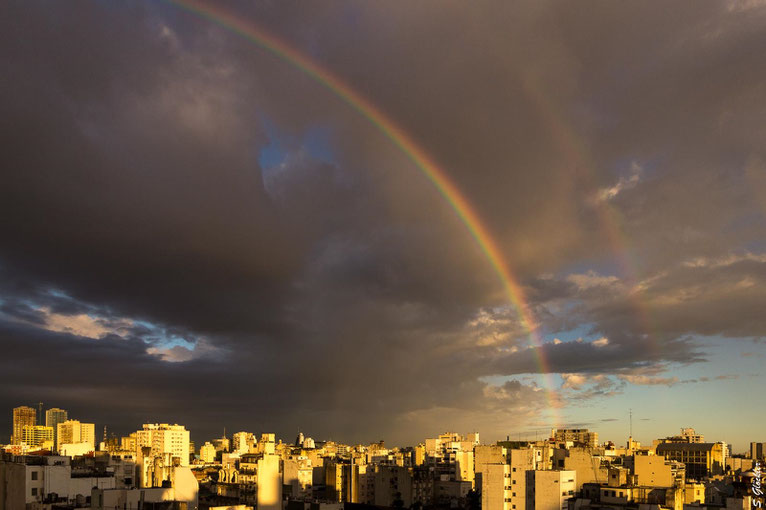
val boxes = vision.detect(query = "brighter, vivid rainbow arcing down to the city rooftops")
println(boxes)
[167,0,560,426]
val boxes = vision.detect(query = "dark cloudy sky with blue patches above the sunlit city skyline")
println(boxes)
[0,0,766,451]
